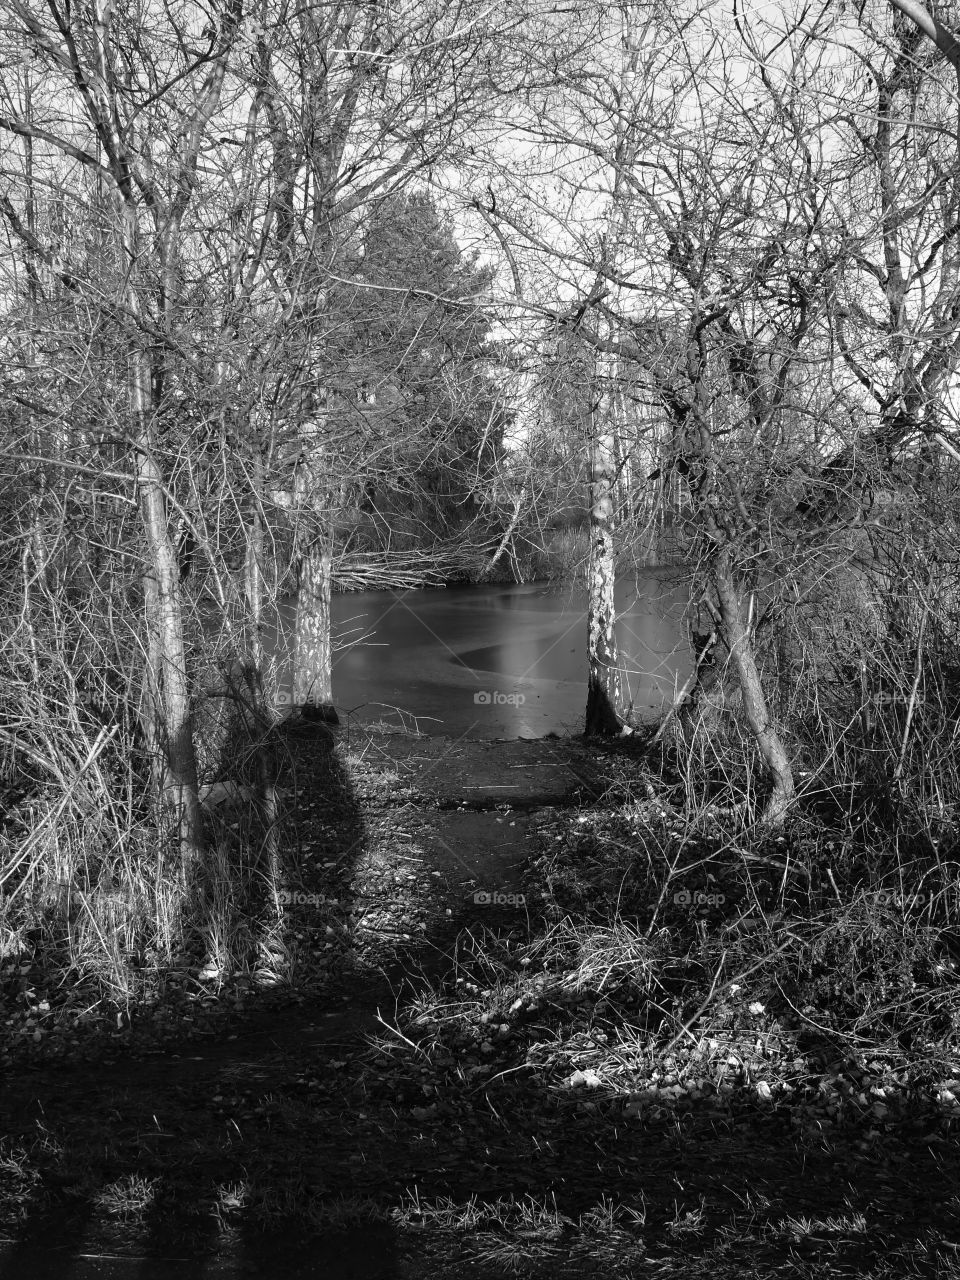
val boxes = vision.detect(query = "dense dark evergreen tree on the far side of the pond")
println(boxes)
[329,193,509,550]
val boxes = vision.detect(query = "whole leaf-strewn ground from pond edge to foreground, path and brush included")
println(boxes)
[0,730,960,1280]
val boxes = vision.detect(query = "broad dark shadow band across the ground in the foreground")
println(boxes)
[0,1013,960,1280]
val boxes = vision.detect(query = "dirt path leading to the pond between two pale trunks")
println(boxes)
[0,730,593,1080]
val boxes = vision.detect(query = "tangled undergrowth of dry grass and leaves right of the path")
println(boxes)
[384,752,960,1117]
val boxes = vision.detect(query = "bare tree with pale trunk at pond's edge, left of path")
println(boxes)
[217,3,529,717]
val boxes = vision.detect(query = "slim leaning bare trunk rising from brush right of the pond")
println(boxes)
[713,549,794,827]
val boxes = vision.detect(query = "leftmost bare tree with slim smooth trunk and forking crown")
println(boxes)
[0,0,252,872]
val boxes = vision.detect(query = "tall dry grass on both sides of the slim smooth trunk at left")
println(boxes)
[0,555,289,1005]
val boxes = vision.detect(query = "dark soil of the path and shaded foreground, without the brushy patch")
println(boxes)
[0,727,960,1280]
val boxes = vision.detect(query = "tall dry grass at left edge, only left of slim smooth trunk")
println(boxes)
[0,607,183,1000]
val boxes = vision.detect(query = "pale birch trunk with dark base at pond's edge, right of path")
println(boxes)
[586,413,630,736]
